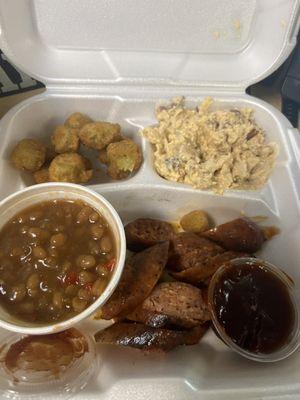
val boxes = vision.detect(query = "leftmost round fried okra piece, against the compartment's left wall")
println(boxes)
[10,138,46,172]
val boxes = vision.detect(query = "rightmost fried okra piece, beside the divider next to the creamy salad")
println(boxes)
[107,139,142,180]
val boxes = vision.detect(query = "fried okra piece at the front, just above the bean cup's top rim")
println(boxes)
[49,153,93,183]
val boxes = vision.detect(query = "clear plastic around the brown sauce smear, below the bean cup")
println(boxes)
[0,329,100,400]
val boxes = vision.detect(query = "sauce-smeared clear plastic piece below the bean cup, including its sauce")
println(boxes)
[0,325,97,400]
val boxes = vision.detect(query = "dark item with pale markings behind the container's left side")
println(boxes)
[0,50,44,97]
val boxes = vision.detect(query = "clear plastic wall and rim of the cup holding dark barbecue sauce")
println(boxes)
[208,257,300,362]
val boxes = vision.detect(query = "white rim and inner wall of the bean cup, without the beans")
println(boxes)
[0,182,126,335]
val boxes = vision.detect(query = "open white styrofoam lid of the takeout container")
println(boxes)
[0,0,300,89]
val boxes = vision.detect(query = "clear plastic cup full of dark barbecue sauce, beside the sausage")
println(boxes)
[208,258,299,362]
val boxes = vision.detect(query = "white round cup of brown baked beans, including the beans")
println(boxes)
[0,183,126,335]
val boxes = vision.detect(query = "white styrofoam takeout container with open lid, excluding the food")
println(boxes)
[0,0,300,400]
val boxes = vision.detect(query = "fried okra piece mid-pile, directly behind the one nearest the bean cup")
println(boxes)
[51,125,79,153]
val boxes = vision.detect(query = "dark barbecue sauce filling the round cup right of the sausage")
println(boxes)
[214,263,295,354]
